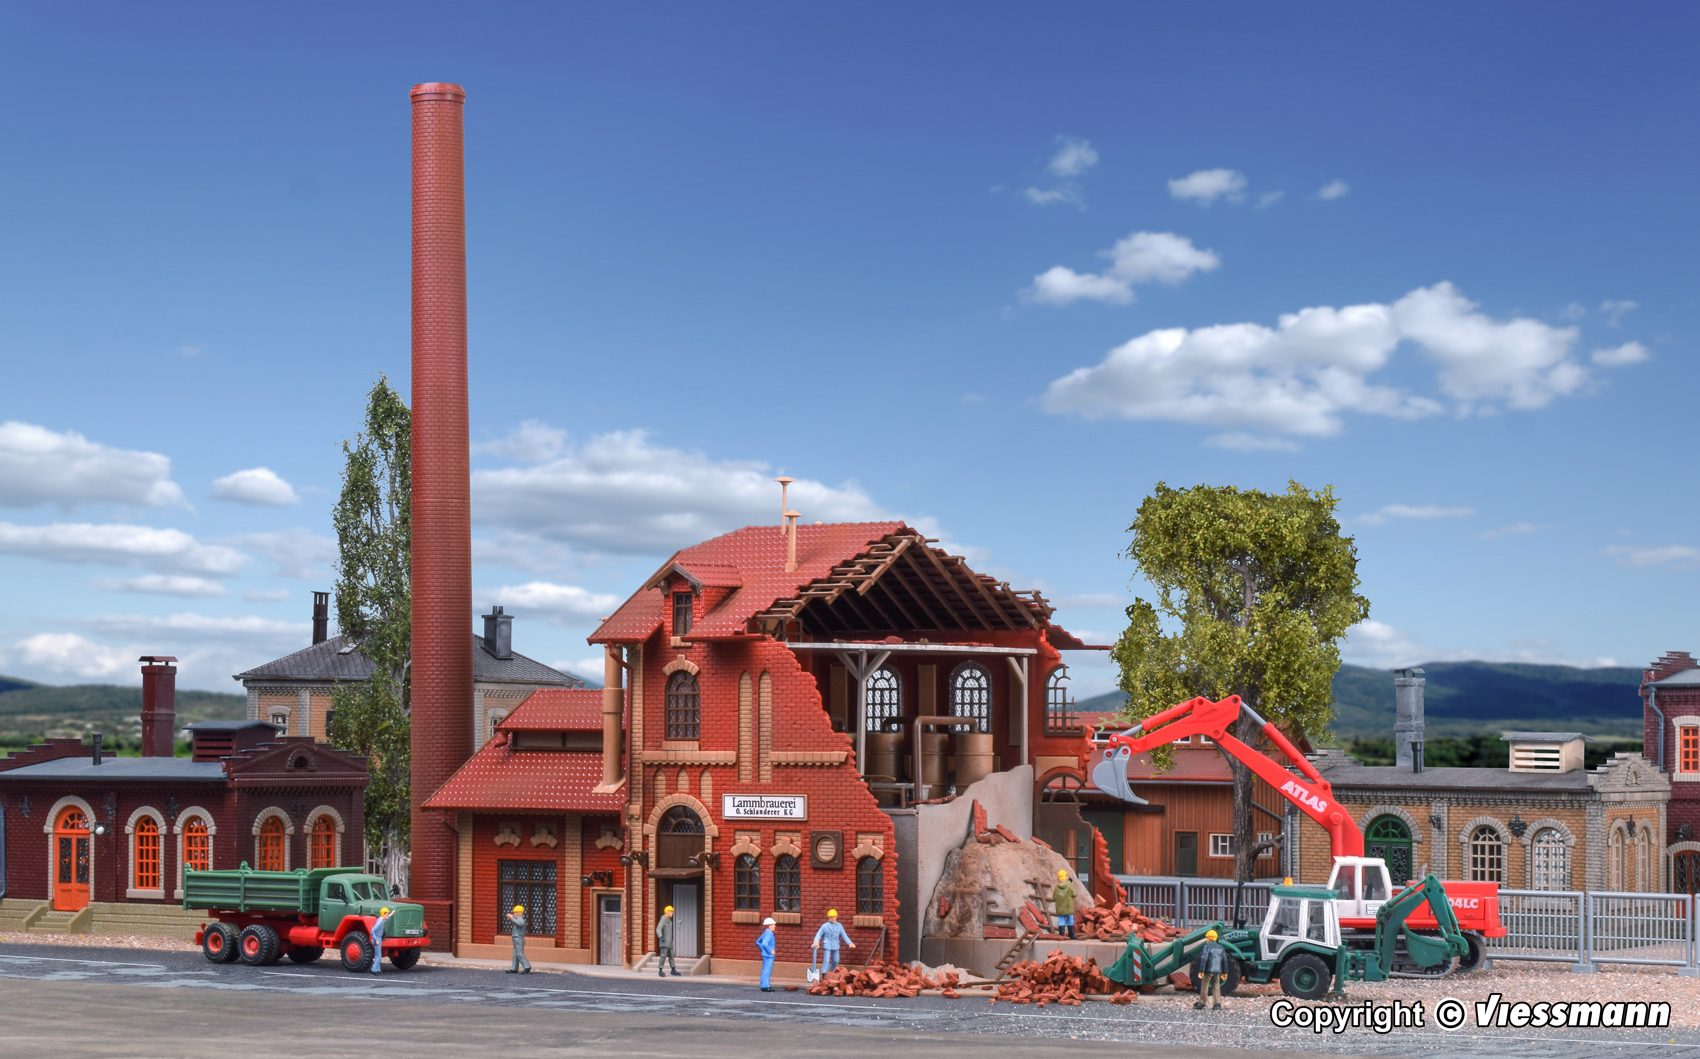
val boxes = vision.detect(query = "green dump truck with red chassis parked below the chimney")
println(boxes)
[184,862,430,971]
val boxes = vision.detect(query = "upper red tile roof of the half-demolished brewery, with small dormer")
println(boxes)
[590,522,908,644]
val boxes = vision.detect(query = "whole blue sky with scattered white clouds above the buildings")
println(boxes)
[0,3,1700,692]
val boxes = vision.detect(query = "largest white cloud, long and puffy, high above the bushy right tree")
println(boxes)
[1040,282,1588,444]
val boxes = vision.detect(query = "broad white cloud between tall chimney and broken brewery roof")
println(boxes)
[473,430,890,556]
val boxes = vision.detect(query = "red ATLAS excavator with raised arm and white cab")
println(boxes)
[1081,695,1506,974]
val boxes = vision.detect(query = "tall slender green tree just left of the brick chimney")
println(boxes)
[328,376,413,886]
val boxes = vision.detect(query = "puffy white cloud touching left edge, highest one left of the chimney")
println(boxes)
[0,422,184,508]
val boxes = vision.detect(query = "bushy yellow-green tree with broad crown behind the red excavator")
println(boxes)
[1112,481,1370,881]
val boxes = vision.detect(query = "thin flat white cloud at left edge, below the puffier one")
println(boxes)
[0,522,248,578]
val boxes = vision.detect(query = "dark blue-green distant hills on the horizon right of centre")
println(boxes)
[1074,661,1641,741]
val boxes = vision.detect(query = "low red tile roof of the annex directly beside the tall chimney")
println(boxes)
[425,741,626,814]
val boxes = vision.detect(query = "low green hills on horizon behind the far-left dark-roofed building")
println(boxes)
[0,677,248,746]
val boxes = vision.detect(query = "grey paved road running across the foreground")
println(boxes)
[0,945,1700,1059]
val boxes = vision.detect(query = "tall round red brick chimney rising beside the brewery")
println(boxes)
[408,83,473,911]
